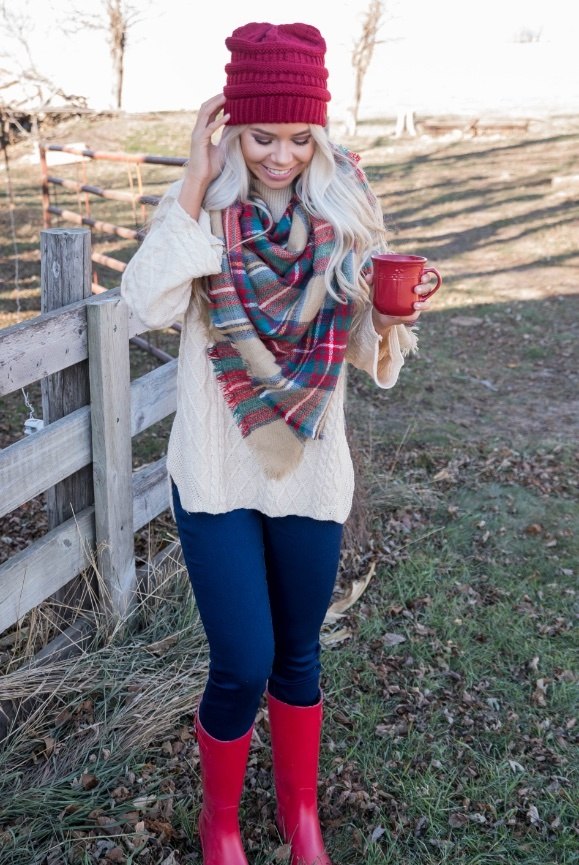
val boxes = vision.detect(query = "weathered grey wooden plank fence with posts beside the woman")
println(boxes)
[0,228,177,633]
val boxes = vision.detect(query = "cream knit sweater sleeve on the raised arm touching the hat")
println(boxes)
[121,181,223,330]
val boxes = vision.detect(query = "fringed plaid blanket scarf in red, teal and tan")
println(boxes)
[208,196,353,478]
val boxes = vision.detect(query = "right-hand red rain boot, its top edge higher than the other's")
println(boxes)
[267,694,332,865]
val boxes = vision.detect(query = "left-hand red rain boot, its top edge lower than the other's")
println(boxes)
[196,716,253,865]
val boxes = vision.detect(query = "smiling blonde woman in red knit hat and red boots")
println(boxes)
[122,23,436,865]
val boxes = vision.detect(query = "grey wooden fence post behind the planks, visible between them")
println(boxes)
[40,228,93,621]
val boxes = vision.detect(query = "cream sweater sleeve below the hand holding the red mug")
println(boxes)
[346,306,417,389]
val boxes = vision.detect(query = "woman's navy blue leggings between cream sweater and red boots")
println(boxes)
[173,485,342,740]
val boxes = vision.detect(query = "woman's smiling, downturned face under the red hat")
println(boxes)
[241,123,316,189]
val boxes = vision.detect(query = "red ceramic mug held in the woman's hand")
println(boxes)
[372,254,442,316]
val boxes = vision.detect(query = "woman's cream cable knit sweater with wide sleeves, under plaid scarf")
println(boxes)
[121,181,415,523]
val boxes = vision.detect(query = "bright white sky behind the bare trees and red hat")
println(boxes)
[0,0,579,116]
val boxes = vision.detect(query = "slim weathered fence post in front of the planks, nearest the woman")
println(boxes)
[87,297,136,617]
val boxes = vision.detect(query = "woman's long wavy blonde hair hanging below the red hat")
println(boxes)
[203,124,387,304]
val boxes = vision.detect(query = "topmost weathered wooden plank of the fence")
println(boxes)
[0,288,147,396]
